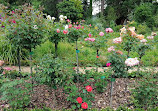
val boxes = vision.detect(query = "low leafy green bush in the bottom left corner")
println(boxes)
[0,79,31,108]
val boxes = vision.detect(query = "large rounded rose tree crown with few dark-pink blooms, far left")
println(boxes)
[5,5,44,49]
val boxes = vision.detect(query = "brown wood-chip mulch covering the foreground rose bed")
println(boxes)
[0,78,135,110]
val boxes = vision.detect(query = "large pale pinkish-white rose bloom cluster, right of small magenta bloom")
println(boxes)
[125,57,139,67]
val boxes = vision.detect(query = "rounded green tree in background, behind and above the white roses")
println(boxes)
[57,0,83,21]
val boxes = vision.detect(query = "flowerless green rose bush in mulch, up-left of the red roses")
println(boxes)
[35,54,68,89]
